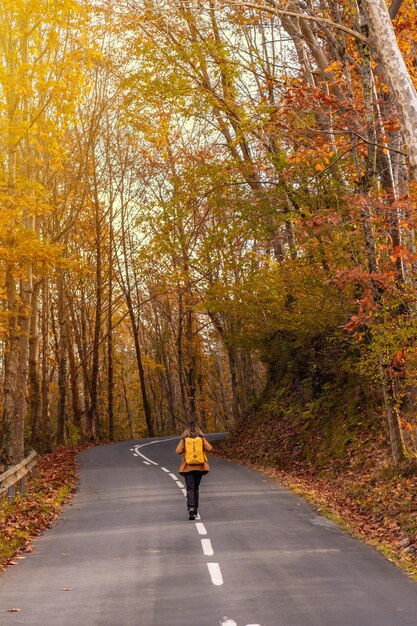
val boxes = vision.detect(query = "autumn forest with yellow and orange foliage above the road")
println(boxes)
[0,0,417,466]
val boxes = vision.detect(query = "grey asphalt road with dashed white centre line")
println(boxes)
[0,440,417,626]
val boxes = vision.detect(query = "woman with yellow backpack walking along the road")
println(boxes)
[176,421,213,519]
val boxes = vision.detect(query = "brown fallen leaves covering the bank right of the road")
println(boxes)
[215,423,417,575]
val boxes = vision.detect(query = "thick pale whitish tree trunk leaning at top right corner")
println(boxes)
[362,0,417,180]
